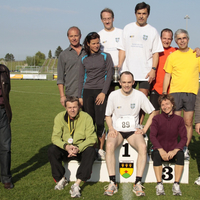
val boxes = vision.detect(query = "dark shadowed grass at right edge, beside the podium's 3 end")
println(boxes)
[189,135,200,174]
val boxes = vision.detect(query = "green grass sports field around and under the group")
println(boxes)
[0,80,200,200]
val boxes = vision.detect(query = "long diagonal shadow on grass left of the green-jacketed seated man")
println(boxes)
[11,144,51,183]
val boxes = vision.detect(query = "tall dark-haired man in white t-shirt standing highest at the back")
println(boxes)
[118,2,163,122]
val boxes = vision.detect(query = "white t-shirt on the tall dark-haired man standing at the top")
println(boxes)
[118,22,164,81]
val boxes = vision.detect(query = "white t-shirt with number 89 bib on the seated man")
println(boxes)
[105,89,155,132]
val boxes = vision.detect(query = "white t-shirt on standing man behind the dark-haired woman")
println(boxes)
[99,28,122,66]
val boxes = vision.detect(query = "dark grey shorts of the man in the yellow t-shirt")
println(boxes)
[171,92,196,111]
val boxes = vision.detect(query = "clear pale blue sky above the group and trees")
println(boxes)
[0,0,200,60]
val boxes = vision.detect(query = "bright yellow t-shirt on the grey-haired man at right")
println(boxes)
[164,48,200,94]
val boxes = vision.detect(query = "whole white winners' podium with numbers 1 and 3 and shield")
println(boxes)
[64,137,189,183]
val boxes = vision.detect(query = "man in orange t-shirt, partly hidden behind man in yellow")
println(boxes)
[150,28,177,114]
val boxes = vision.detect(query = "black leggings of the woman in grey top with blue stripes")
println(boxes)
[83,89,107,137]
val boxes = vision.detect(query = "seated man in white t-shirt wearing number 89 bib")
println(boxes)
[104,71,155,196]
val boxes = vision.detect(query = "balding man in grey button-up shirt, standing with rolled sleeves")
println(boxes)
[57,26,85,106]
